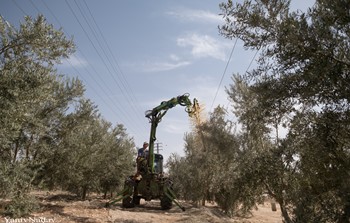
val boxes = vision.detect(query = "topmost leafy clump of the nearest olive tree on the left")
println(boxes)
[0,15,74,64]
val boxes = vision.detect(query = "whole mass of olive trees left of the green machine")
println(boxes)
[0,16,134,217]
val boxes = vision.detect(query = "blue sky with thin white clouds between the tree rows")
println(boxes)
[0,0,314,159]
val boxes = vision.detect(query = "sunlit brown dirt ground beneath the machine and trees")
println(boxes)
[0,193,282,223]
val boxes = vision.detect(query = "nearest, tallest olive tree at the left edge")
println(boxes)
[0,13,83,215]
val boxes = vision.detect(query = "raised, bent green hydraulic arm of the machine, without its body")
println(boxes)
[145,94,199,173]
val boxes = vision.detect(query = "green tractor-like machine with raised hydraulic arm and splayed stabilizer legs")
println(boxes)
[109,94,199,211]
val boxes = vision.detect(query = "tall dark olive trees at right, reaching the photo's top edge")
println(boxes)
[220,0,350,222]
